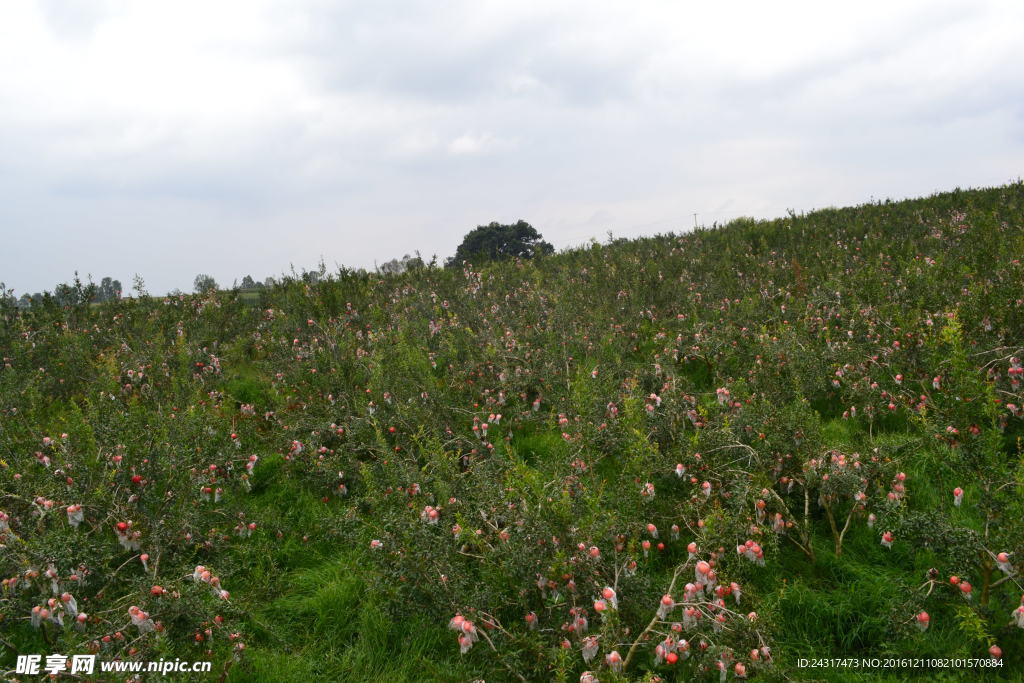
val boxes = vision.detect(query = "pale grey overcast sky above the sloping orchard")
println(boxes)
[0,0,1024,294]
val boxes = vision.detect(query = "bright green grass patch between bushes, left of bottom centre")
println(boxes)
[222,464,483,682]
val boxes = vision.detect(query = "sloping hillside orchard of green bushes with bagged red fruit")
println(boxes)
[0,182,1024,682]
